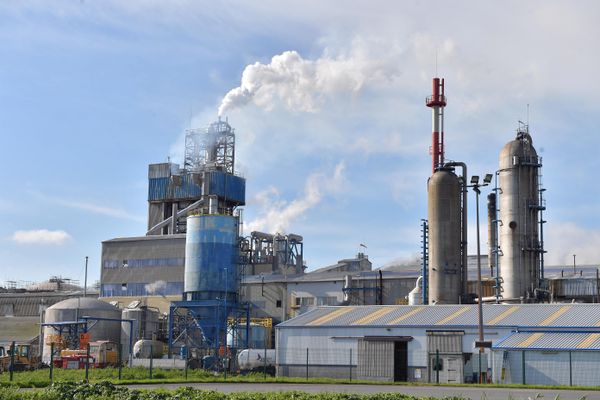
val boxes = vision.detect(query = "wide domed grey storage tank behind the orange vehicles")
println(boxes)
[42,297,121,363]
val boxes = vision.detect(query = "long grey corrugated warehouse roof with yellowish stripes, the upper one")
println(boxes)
[278,304,600,329]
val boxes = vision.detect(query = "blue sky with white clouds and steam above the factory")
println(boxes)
[0,0,600,281]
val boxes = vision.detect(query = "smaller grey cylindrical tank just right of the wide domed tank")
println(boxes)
[121,306,159,358]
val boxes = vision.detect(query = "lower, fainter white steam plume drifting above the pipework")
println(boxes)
[246,162,345,233]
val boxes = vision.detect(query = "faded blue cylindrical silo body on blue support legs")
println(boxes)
[184,215,238,301]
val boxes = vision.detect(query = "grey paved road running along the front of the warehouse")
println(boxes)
[127,383,600,400]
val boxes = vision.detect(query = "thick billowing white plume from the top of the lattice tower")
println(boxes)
[219,46,397,115]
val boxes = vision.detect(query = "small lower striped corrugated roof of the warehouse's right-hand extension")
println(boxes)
[492,332,600,351]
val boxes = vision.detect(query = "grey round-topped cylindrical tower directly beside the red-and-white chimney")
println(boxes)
[427,169,461,304]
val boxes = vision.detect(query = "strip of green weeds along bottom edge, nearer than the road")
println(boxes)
[0,382,438,400]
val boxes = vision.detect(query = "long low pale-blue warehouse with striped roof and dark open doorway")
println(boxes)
[276,303,600,385]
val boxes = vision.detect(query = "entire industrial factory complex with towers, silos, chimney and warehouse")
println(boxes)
[0,78,600,385]
